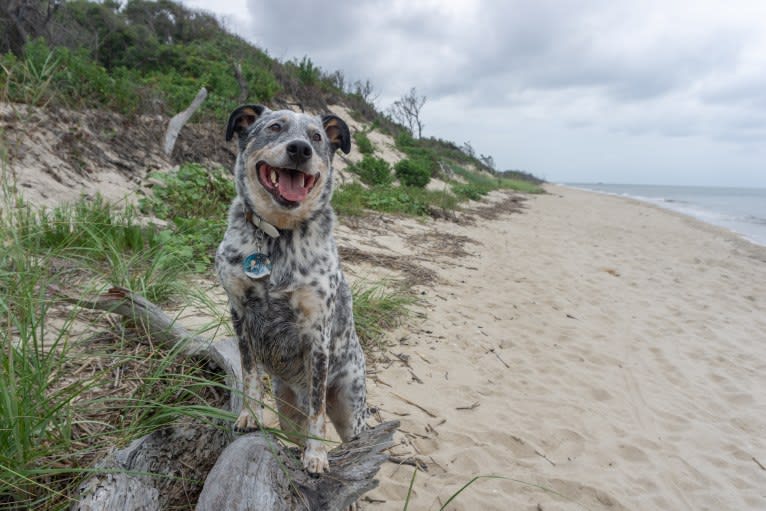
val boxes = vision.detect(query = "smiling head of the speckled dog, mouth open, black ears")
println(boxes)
[226,105,351,229]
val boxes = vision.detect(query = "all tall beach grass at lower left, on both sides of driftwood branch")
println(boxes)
[0,158,231,510]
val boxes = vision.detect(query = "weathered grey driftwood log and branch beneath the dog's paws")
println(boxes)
[50,287,399,511]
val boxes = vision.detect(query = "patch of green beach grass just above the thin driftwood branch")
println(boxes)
[9,193,188,302]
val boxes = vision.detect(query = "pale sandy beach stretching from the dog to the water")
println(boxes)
[337,186,766,511]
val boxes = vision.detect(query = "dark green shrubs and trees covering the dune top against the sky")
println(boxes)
[0,0,548,186]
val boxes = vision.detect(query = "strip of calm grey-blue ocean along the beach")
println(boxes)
[566,183,766,246]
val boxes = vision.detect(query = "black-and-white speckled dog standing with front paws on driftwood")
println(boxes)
[215,105,368,475]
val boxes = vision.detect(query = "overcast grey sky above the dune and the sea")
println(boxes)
[182,0,766,188]
